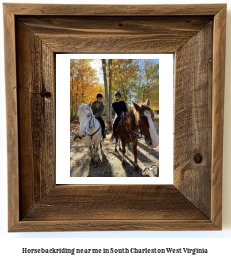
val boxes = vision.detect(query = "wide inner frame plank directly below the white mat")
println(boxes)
[23,185,207,221]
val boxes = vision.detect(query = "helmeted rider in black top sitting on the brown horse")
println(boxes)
[112,91,128,143]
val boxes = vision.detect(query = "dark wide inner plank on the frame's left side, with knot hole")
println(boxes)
[16,20,55,218]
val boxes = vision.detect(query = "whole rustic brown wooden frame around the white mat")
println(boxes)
[3,4,226,232]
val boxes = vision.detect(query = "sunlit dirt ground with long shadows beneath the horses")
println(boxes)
[70,121,159,177]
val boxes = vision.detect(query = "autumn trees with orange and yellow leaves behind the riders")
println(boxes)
[70,59,159,124]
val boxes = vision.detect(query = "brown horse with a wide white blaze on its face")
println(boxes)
[110,100,159,170]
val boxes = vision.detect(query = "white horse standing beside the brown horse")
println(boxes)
[76,102,102,163]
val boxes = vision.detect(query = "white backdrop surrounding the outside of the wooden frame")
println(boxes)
[0,0,231,260]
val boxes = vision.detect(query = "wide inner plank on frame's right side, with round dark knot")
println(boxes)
[174,22,213,218]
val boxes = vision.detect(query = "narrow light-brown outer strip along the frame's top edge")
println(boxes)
[4,3,224,16]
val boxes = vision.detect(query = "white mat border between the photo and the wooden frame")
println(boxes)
[56,54,173,184]
